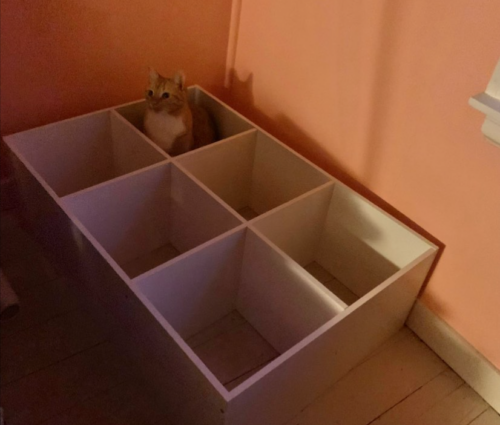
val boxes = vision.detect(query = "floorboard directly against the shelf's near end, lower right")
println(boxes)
[289,328,448,425]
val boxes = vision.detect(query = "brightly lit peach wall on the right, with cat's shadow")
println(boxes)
[227,0,500,368]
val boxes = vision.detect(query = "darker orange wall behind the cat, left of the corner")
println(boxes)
[1,0,231,135]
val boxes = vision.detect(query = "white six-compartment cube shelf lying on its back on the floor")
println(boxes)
[5,86,437,425]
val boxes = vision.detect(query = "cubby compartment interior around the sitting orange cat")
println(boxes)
[116,86,253,147]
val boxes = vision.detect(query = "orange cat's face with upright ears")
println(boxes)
[145,69,187,112]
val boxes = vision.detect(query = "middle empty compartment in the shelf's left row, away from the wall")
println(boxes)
[62,164,241,277]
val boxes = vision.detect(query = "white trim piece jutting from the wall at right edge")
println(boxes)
[469,61,500,146]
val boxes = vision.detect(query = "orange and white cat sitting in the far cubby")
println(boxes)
[144,68,215,155]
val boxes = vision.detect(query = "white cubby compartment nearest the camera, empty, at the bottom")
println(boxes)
[134,229,343,390]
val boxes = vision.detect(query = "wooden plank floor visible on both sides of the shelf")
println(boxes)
[0,210,500,425]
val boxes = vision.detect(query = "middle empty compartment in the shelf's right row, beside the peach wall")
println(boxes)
[178,130,331,220]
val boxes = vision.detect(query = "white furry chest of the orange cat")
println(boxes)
[144,111,186,149]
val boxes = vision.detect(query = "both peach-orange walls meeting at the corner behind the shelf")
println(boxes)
[1,0,500,367]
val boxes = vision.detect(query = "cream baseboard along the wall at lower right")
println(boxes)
[406,301,500,413]
